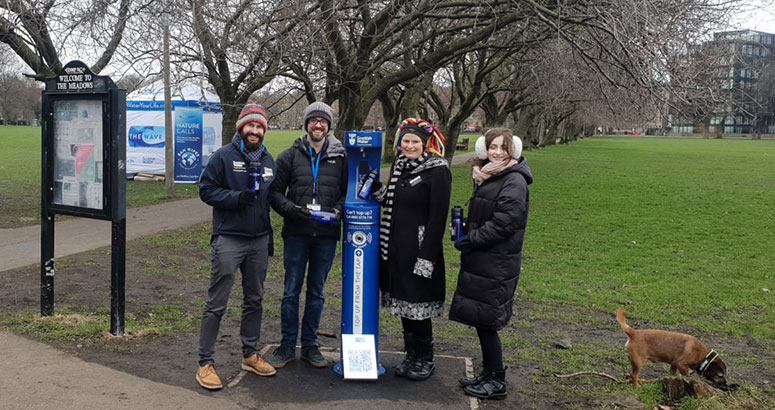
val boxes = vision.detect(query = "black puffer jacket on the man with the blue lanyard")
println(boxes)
[269,134,348,239]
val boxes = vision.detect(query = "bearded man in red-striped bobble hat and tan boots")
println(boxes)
[196,102,276,389]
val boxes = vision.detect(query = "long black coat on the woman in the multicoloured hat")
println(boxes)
[379,160,452,308]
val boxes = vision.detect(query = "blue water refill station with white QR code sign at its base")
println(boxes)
[334,131,385,379]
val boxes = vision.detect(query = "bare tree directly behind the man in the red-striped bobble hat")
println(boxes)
[178,0,304,143]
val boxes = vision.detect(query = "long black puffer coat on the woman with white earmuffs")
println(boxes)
[449,158,533,330]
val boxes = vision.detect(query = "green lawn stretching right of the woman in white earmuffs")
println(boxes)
[504,138,775,343]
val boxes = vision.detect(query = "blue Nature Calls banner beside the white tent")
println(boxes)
[175,107,202,182]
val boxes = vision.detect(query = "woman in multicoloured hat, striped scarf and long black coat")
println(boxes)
[374,118,452,380]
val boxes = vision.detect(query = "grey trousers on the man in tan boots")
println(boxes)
[199,235,269,366]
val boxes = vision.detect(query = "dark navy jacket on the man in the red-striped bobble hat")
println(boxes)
[199,144,277,238]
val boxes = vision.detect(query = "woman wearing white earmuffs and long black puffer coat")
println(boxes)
[449,128,533,400]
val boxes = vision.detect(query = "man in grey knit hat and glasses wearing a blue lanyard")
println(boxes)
[267,102,347,368]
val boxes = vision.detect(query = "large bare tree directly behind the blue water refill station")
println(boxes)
[297,0,532,141]
